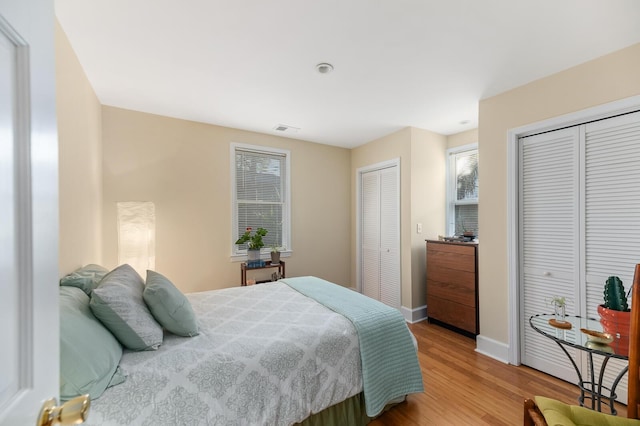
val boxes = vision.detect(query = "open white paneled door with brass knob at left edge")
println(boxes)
[0,0,59,425]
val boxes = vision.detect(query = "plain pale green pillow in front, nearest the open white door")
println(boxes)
[59,287,124,400]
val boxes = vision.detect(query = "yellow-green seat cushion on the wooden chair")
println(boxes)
[535,396,640,426]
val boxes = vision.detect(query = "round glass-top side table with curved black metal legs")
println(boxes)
[529,314,629,414]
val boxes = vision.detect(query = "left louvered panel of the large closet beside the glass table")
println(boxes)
[519,128,579,383]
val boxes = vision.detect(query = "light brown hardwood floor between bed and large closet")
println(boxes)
[371,321,627,426]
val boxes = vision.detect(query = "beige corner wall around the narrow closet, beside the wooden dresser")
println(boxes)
[351,127,446,309]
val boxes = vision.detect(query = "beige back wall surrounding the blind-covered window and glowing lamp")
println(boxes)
[102,106,351,292]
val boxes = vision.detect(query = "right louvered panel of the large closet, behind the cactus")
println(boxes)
[584,113,640,403]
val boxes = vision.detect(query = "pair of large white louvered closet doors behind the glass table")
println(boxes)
[520,112,640,403]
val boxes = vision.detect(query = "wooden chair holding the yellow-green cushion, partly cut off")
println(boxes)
[524,264,640,426]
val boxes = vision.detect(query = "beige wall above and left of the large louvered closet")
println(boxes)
[478,44,640,344]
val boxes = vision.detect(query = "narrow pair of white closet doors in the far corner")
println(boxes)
[358,162,401,309]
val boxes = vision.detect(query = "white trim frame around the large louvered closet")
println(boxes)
[507,96,640,365]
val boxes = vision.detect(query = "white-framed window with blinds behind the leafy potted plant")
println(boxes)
[231,144,291,257]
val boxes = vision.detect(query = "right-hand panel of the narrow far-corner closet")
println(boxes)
[380,167,400,309]
